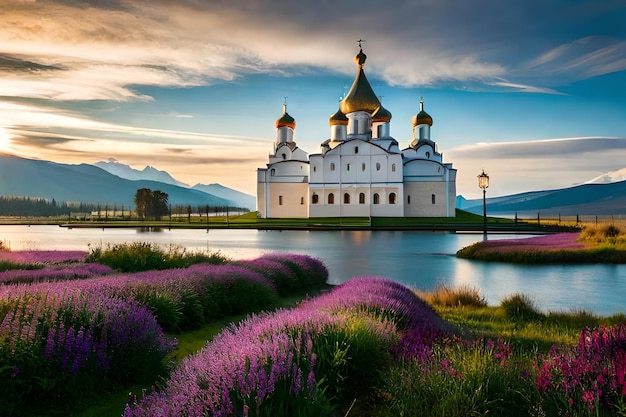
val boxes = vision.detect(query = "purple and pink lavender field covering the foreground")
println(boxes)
[0,247,626,417]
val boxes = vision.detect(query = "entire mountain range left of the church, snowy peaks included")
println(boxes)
[0,154,256,210]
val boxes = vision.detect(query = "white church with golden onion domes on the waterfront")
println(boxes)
[257,45,456,218]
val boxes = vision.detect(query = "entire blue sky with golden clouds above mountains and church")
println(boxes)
[0,0,626,198]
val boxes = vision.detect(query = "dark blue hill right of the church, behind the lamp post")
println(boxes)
[456,181,626,215]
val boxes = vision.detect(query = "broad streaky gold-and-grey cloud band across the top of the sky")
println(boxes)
[7,0,625,101]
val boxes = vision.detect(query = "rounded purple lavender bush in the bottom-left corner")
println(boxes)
[0,284,174,417]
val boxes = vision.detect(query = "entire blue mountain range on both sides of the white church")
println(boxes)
[0,154,626,216]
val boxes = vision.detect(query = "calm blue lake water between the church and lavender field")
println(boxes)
[0,226,626,315]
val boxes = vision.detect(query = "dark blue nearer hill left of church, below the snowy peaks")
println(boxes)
[0,155,249,207]
